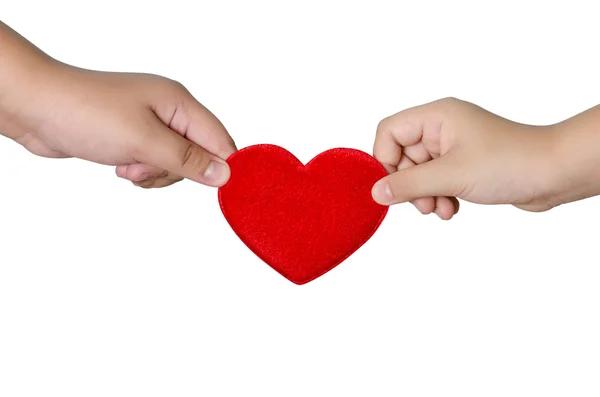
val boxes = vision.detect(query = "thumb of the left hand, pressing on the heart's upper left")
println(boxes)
[135,123,230,187]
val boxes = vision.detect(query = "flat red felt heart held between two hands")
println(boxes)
[219,145,388,284]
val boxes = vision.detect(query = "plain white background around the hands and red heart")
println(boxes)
[0,0,600,397]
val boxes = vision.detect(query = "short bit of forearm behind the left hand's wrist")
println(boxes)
[0,22,56,139]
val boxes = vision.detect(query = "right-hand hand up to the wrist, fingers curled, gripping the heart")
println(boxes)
[373,99,564,220]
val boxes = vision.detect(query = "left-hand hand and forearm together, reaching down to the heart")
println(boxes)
[0,22,236,188]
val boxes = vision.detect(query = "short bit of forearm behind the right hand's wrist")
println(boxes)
[554,105,600,203]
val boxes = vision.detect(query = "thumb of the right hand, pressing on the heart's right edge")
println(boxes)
[372,155,461,205]
